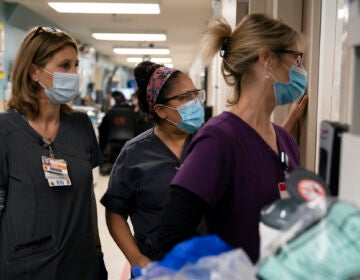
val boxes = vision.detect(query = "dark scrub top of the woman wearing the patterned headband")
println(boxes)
[101,128,191,260]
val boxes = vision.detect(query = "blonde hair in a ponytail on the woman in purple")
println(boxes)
[202,14,300,105]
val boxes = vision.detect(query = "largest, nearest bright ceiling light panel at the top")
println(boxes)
[48,2,160,14]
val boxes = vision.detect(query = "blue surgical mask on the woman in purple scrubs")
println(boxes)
[271,65,307,105]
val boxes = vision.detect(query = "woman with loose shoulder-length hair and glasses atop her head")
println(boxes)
[0,26,107,280]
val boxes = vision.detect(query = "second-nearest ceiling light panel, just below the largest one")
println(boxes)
[92,33,166,41]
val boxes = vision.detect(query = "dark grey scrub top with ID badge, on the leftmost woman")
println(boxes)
[0,110,101,280]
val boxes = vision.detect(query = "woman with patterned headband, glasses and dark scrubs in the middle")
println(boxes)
[101,62,205,274]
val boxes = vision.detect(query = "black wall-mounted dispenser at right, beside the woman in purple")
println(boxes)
[319,121,349,196]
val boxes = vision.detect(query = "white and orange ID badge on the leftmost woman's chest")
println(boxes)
[41,156,71,187]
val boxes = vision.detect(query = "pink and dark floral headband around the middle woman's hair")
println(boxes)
[146,66,176,112]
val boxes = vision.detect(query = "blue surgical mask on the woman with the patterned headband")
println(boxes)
[163,98,205,133]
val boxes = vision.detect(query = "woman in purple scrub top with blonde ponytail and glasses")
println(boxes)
[158,14,307,263]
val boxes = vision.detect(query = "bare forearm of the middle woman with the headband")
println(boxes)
[106,209,151,267]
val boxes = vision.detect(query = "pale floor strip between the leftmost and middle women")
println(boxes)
[94,169,129,280]
